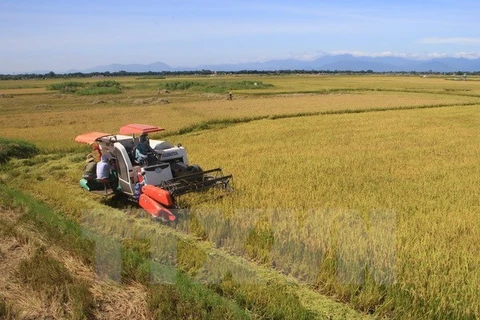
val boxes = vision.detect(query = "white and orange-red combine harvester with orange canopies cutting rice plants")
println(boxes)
[75,124,232,221]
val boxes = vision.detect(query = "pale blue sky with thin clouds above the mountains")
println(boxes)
[0,0,480,73]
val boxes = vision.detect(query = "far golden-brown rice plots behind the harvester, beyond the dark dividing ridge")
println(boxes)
[0,76,480,151]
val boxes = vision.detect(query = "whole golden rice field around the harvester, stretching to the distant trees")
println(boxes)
[0,75,480,319]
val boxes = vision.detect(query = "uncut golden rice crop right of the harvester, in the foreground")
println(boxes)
[172,107,480,318]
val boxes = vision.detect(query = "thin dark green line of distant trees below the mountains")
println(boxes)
[0,69,480,80]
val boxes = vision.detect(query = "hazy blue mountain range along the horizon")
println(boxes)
[67,54,480,73]
